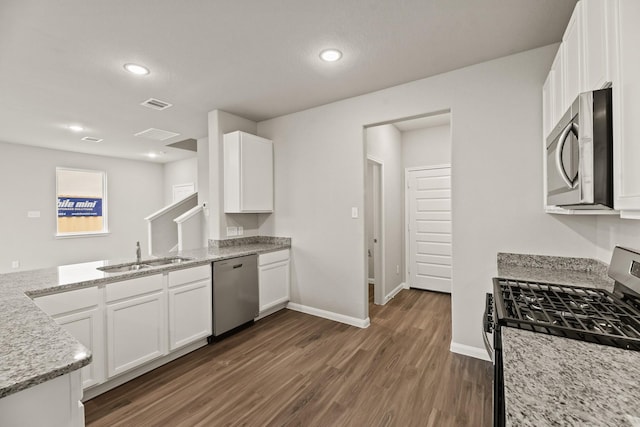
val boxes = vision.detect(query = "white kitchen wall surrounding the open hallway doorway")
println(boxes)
[258,45,596,349]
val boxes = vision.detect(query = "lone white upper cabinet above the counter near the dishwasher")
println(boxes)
[224,131,273,213]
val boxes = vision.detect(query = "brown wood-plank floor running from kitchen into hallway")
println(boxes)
[85,290,493,427]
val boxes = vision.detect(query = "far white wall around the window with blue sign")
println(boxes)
[0,143,163,273]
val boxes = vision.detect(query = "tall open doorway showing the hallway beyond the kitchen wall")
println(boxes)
[363,110,452,318]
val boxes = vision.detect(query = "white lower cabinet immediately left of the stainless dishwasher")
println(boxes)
[168,264,213,350]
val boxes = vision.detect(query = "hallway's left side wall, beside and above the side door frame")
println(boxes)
[366,125,404,297]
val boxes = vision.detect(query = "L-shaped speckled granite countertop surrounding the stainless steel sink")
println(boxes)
[0,238,291,398]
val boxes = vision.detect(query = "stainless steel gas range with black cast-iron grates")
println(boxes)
[483,247,640,427]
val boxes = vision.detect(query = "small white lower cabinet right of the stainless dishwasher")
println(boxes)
[258,249,290,314]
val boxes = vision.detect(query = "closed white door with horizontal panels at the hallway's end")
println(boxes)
[407,165,451,293]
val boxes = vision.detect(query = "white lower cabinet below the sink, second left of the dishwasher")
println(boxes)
[106,274,167,377]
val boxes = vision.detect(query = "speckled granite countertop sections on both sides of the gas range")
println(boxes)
[498,254,640,427]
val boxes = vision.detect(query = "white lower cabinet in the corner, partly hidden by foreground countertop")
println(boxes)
[34,286,105,389]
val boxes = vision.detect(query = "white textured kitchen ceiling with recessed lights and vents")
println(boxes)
[0,0,576,162]
